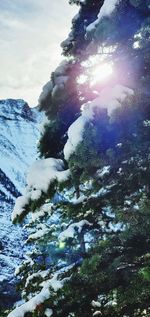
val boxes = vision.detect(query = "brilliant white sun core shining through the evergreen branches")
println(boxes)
[91,63,113,85]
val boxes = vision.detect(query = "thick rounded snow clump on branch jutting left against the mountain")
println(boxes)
[12,158,70,221]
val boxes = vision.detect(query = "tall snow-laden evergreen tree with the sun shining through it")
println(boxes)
[9,0,150,317]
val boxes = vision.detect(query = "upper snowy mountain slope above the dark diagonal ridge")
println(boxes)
[0,99,40,199]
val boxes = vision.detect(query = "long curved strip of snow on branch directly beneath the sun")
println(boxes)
[64,84,134,161]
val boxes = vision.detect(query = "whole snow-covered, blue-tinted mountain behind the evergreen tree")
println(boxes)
[0,99,41,306]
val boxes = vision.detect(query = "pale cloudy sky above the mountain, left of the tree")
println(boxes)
[0,0,77,107]
